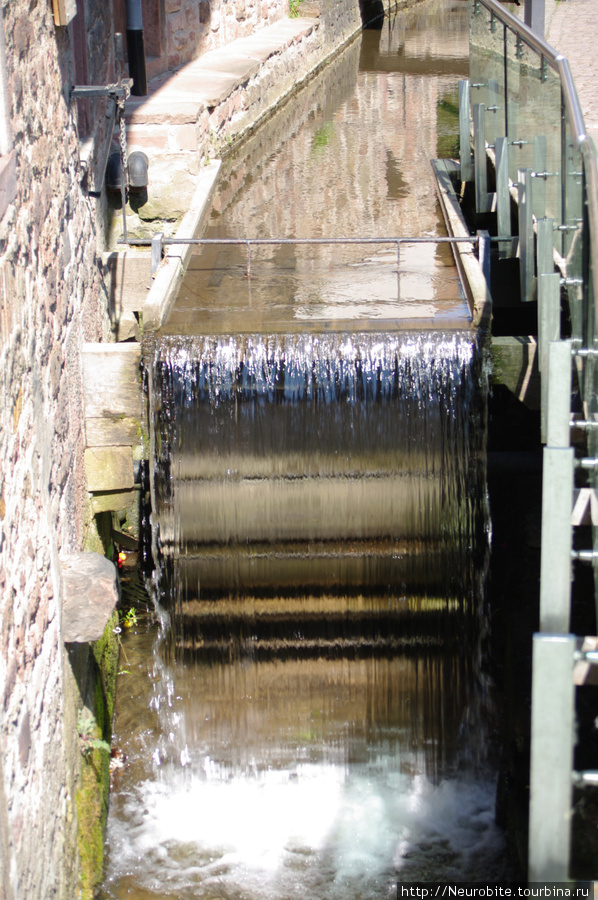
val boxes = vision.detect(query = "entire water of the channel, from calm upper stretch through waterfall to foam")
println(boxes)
[100,0,508,900]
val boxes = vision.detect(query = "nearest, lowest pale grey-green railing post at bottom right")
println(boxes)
[528,634,575,883]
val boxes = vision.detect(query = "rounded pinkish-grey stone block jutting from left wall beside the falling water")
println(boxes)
[61,553,118,644]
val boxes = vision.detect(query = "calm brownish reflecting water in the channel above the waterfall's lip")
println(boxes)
[165,0,469,334]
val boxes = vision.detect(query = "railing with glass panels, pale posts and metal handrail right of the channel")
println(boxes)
[468,0,598,882]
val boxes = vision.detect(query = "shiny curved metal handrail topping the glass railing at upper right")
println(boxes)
[476,0,598,334]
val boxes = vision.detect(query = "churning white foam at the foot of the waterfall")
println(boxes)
[108,759,505,900]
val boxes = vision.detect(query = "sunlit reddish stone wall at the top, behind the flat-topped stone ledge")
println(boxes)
[165,0,289,69]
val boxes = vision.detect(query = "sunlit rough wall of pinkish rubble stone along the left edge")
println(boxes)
[0,0,110,900]
